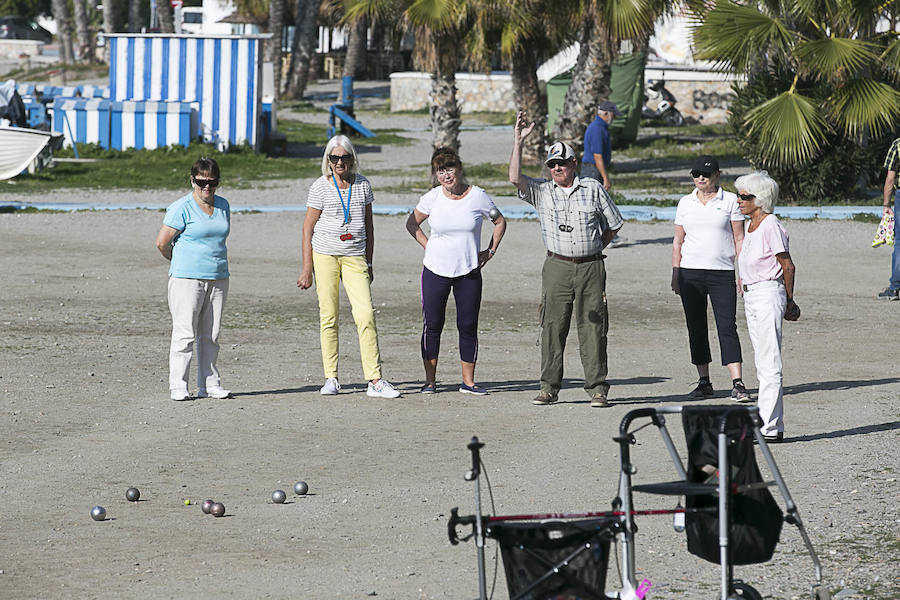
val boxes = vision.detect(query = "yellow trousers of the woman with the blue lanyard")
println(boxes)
[313,252,381,380]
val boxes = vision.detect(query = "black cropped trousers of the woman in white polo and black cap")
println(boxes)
[678,269,743,365]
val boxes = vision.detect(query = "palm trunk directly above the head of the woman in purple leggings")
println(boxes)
[428,33,462,152]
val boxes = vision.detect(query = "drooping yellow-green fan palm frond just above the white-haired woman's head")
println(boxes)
[744,90,828,166]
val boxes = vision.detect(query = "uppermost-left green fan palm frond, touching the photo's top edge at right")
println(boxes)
[693,0,795,71]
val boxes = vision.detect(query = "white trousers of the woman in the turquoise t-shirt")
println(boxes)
[169,277,228,391]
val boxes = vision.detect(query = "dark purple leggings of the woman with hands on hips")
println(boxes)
[422,267,481,363]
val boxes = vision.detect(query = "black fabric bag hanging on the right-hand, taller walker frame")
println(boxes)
[682,406,784,565]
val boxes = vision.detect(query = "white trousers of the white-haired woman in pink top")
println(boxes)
[744,281,787,435]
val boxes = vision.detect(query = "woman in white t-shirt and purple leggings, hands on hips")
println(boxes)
[406,148,506,396]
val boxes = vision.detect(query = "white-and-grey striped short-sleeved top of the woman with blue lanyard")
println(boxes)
[306,173,375,256]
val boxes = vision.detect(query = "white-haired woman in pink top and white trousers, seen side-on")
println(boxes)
[734,171,800,443]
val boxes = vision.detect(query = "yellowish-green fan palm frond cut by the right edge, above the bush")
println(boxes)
[826,78,900,137]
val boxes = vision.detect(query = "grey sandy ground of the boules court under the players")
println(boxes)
[0,203,900,599]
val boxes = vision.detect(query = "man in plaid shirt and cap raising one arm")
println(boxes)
[509,112,623,408]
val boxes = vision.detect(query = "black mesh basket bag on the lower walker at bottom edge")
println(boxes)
[487,519,617,600]
